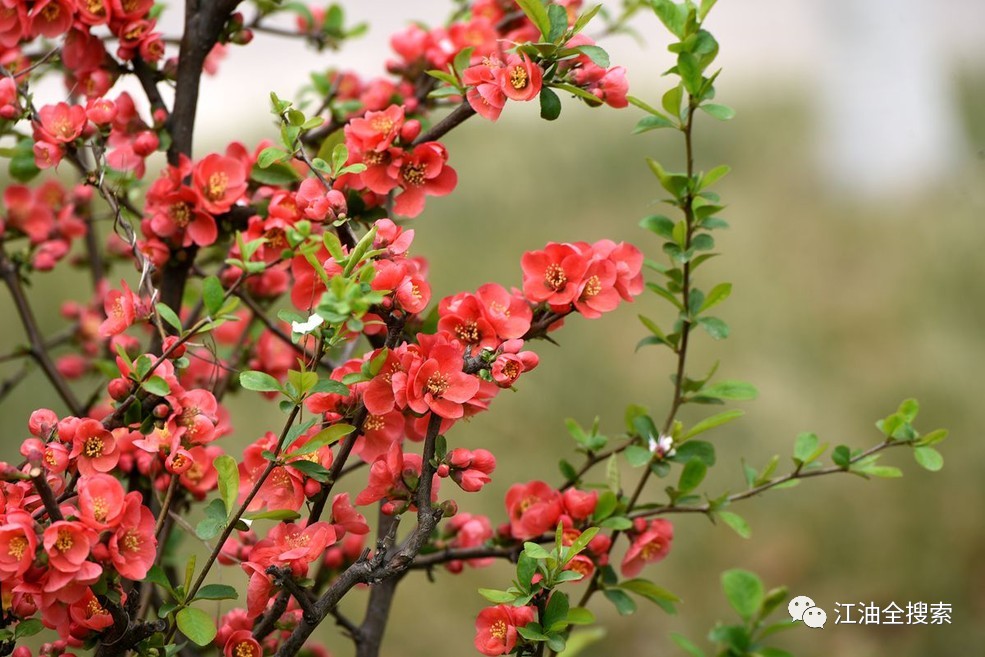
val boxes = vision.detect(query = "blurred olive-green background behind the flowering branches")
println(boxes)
[0,2,985,657]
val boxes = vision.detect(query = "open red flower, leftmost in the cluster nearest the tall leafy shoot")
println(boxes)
[520,243,588,307]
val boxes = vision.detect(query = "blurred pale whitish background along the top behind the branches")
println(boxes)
[125,0,985,195]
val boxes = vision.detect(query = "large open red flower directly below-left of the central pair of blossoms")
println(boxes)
[407,344,479,420]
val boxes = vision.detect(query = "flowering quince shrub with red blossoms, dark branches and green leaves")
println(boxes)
[0,0,946,657]
